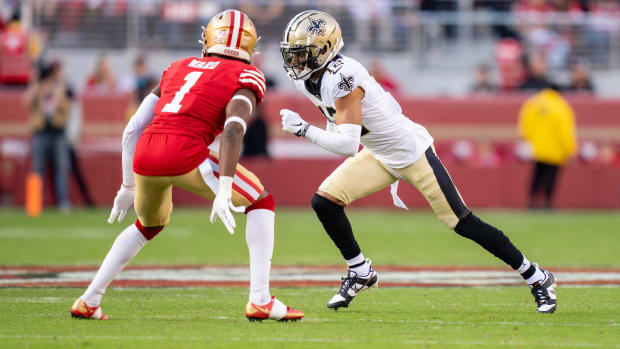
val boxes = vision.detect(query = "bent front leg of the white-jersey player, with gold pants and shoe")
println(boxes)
[312,149,396,309]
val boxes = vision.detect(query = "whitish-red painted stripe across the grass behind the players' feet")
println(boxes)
[0,266,620,287]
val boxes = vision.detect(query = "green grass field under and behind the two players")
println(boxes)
[0,209,620,348]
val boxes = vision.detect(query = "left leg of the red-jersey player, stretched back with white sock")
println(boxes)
[71,174,172,319]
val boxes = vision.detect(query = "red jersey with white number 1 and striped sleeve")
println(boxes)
[134,57,266,176]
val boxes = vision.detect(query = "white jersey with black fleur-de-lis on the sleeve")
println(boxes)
[294,55,433,168]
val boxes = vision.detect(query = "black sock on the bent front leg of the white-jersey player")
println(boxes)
[311,194,362,260]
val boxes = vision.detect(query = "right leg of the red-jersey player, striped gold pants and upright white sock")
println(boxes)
[173,152,304,320]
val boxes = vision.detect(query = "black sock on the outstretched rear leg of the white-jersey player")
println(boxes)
[454,213,523,270]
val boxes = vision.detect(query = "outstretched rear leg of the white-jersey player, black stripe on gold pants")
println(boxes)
[396,147,556,312]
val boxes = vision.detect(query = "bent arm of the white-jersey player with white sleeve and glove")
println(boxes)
[280,87,364,156]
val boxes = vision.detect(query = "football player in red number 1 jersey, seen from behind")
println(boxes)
[71,10,304,320]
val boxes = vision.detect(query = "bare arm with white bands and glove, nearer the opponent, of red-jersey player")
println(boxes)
[211,88,256,234]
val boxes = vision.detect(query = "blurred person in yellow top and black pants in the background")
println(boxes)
[519,86,577,209]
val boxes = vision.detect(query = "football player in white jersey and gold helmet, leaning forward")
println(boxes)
[280,10,557,313]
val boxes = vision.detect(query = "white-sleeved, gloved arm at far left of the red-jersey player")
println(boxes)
[108,86,160,223]
